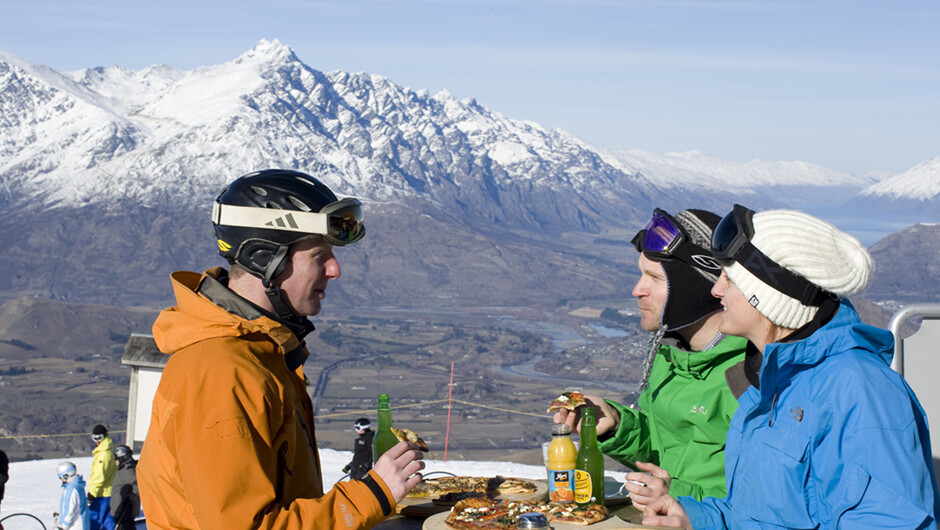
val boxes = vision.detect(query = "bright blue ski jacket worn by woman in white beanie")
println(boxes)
[679,301,940,530]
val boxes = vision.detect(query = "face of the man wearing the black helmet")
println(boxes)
[280,238,340,316]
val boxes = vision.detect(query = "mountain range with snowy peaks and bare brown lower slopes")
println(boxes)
[0,41,936,304]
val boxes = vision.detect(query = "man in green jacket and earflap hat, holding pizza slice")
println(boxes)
[554,209,747,509]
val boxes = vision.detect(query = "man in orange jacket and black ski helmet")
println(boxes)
[137,169,424,530]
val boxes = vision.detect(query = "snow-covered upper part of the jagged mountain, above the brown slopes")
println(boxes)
[0,41,668,230]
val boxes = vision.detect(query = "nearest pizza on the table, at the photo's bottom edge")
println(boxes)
[444,498,610,530]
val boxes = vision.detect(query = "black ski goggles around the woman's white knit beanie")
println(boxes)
[712,204,837,307]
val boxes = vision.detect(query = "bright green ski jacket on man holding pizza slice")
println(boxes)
[599,336,747,500]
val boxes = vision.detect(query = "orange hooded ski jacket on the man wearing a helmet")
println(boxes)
[137,268,395,530]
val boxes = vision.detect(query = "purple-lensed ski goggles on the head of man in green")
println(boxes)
[630,208,721,271]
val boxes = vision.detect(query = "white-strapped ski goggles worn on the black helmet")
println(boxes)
[212,197,366,246]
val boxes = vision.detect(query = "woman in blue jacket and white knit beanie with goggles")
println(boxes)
[643,205,940,529]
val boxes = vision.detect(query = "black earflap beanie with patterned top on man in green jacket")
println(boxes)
[659,210,721,331]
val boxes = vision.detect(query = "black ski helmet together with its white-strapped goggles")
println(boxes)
[212,169,365,286]
